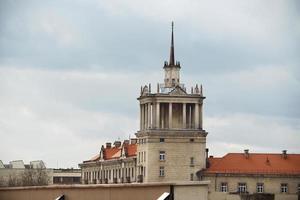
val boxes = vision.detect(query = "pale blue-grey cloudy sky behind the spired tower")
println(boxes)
[0,0,300,167]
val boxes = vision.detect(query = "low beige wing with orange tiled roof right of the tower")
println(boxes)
[197,150,300,200]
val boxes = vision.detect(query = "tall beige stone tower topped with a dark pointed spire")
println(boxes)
[136,22,207,182]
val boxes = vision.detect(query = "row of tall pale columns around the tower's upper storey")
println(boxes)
[140,102,202,130]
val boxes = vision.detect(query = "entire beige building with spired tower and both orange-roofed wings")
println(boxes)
[79,23,300,200]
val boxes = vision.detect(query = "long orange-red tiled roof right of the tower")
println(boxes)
[205,153,300,175]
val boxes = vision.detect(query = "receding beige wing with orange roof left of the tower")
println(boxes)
[79,139,138,184]
